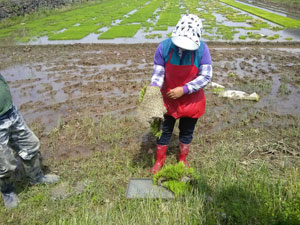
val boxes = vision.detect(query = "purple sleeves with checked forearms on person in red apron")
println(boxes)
[151,42,212,94]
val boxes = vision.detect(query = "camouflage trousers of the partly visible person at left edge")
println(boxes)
[0,106,41,188]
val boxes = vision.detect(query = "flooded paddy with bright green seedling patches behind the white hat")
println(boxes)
[0,0,300,45]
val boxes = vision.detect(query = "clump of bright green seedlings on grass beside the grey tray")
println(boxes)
[153,162,198,197]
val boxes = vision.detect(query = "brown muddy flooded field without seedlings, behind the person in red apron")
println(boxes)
[0,44,300,130]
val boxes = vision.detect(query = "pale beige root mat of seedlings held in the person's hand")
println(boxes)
[137,86,166,127]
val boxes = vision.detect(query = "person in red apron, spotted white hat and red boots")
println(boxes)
[151,14,212,174]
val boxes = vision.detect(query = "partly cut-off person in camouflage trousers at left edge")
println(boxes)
[0,74,59,208]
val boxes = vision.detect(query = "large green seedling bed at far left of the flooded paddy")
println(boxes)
[0,0,145,42]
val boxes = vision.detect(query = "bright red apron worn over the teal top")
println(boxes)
[161,49,205,119]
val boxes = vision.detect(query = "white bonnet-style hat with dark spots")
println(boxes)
[171,14,202,51]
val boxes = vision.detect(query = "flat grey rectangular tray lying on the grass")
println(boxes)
[126,178,174,198]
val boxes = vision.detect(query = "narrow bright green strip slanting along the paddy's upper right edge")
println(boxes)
[219,0,300,28]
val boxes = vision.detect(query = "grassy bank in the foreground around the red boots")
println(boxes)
[0,111,300,225]
